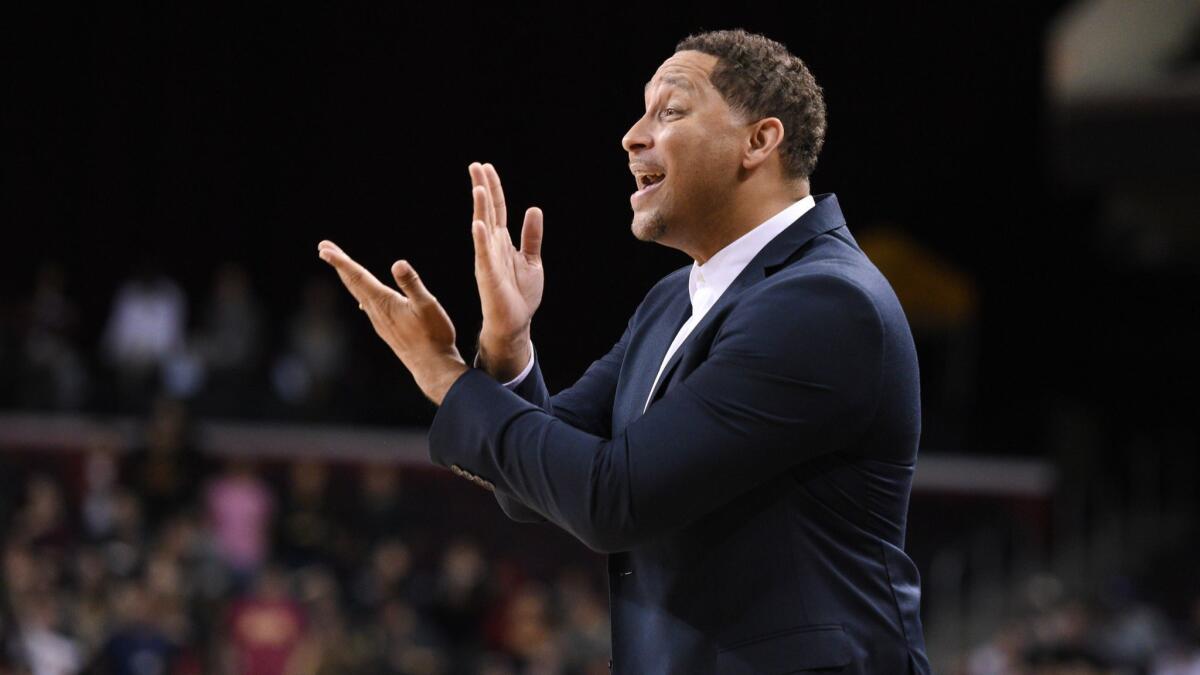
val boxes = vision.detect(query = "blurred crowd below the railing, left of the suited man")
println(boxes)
[0,396,610,675]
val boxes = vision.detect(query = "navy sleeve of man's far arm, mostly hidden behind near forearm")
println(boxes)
[494,321,632,522]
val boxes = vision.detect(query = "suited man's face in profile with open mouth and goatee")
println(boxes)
[622,52,745,249]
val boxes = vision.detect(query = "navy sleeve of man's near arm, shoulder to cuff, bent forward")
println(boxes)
[430,274,884,552]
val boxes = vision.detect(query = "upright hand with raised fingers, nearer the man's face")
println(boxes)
[468,162,545,380]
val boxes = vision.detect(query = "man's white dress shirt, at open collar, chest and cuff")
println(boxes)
[487,195,816,410]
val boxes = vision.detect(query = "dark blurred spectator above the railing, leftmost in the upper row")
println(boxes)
[17,263,89,410]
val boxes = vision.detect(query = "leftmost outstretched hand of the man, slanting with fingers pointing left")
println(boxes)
[317,241,467,405]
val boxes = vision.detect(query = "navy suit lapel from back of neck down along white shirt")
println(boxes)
[630,193,846,408]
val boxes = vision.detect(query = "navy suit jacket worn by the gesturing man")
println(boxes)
[430,195,930,675]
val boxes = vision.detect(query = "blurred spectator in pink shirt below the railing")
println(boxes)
[205,459,277,583]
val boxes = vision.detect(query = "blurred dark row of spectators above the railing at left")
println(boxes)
[0,262,396,423]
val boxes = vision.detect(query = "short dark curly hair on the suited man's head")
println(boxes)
[676,29,826,178]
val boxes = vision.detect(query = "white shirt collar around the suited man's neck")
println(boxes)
[688,195,816,313]
